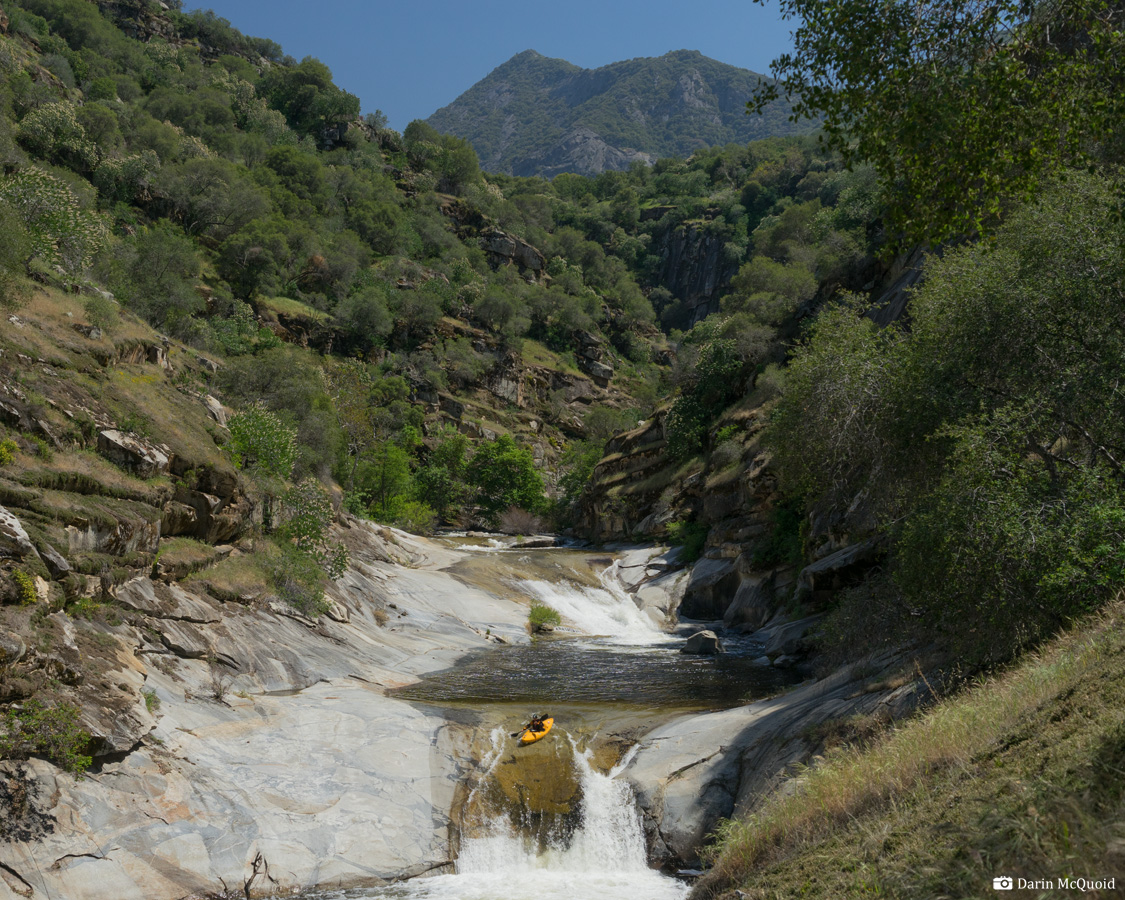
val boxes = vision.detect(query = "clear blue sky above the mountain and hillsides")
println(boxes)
[183,0,790,131]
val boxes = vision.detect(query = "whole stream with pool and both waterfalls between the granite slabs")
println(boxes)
[306,538,785,900]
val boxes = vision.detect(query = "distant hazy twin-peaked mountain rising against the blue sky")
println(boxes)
[426,50,813,178]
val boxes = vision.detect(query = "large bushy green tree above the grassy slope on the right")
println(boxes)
[766,173,1125,662]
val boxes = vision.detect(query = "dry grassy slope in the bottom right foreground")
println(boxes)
[693,601,1125,900]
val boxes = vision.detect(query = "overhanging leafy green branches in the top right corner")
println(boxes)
[749,0,1125,243]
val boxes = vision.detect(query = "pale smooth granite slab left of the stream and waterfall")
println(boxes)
[0,523,527,900]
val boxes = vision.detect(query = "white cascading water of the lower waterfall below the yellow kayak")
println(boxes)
[387,729,686,900]
